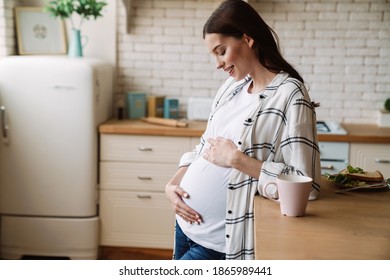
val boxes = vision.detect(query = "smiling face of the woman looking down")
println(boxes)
[205,33,257,81]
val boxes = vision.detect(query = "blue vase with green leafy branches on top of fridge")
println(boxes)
[44,0,107,56]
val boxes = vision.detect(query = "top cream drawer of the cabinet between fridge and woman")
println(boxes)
[100,134,190,163]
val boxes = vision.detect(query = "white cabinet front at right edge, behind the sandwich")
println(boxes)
[350,143,390,178]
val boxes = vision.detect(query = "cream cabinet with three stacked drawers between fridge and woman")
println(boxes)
[100,134,193,249]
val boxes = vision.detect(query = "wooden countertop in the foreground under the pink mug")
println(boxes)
[254,179,390,260]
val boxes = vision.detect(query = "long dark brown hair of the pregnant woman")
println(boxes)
[203,0,304,83]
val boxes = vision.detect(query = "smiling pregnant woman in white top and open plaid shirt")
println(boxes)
[165,0,321,260]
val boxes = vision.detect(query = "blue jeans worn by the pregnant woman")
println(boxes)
[173,222,225,260]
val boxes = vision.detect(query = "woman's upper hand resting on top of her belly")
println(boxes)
[203,137,239,167]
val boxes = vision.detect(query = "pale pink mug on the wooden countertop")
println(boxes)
[264,175,313,217]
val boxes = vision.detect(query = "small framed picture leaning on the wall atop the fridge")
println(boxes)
[15,7,67,55]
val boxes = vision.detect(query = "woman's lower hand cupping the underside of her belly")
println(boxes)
[165,168,202,224]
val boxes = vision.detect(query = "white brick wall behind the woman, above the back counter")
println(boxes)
[117,0,390,123]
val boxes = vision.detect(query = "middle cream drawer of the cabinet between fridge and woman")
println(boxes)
[100,162,178,192]
